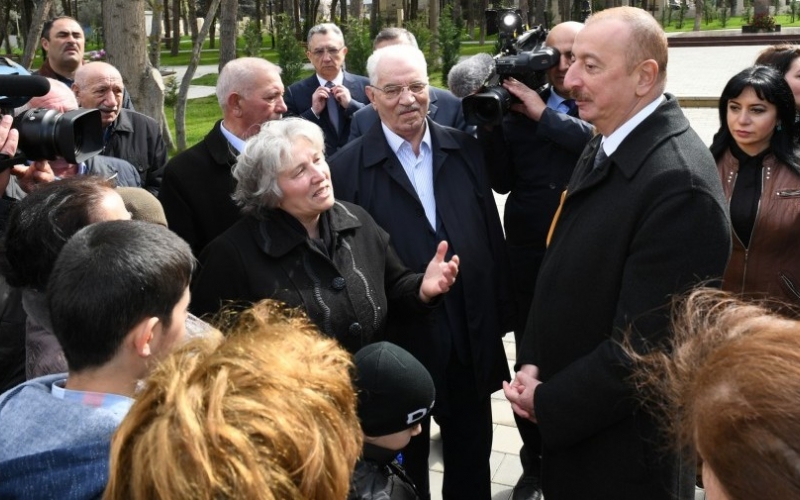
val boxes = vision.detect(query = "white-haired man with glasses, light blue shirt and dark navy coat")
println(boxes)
[329,44,514,500]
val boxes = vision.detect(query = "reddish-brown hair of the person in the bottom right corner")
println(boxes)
[634,289,800,500]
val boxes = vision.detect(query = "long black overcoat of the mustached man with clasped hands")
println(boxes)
[517,95,731,500]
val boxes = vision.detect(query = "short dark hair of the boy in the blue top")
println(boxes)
[47,220,194,372]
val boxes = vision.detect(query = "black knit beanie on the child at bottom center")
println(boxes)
[354,342,436,437]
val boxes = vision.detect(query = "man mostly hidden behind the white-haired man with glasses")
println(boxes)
[348,26,475,142]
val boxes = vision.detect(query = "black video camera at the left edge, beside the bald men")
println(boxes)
[0,57,103,171]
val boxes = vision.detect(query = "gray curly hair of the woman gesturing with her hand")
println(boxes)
[233,117,325,216]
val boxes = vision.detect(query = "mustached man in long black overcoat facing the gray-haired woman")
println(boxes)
[504,7,731,500]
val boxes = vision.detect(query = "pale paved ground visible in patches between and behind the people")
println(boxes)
[175,41,764,500]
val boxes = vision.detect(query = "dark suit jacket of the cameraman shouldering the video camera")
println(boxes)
[478,89,593,334]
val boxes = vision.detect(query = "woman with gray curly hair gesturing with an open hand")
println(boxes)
[192,118,458,353]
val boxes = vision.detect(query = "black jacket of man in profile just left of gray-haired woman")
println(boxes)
[158,120,240,256]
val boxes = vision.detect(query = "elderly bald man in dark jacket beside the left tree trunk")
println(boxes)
[72,61,167,195]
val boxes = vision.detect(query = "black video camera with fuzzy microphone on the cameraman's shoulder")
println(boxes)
[462,10,561,125]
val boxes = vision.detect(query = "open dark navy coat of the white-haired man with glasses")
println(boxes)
[329,116,513,398]
